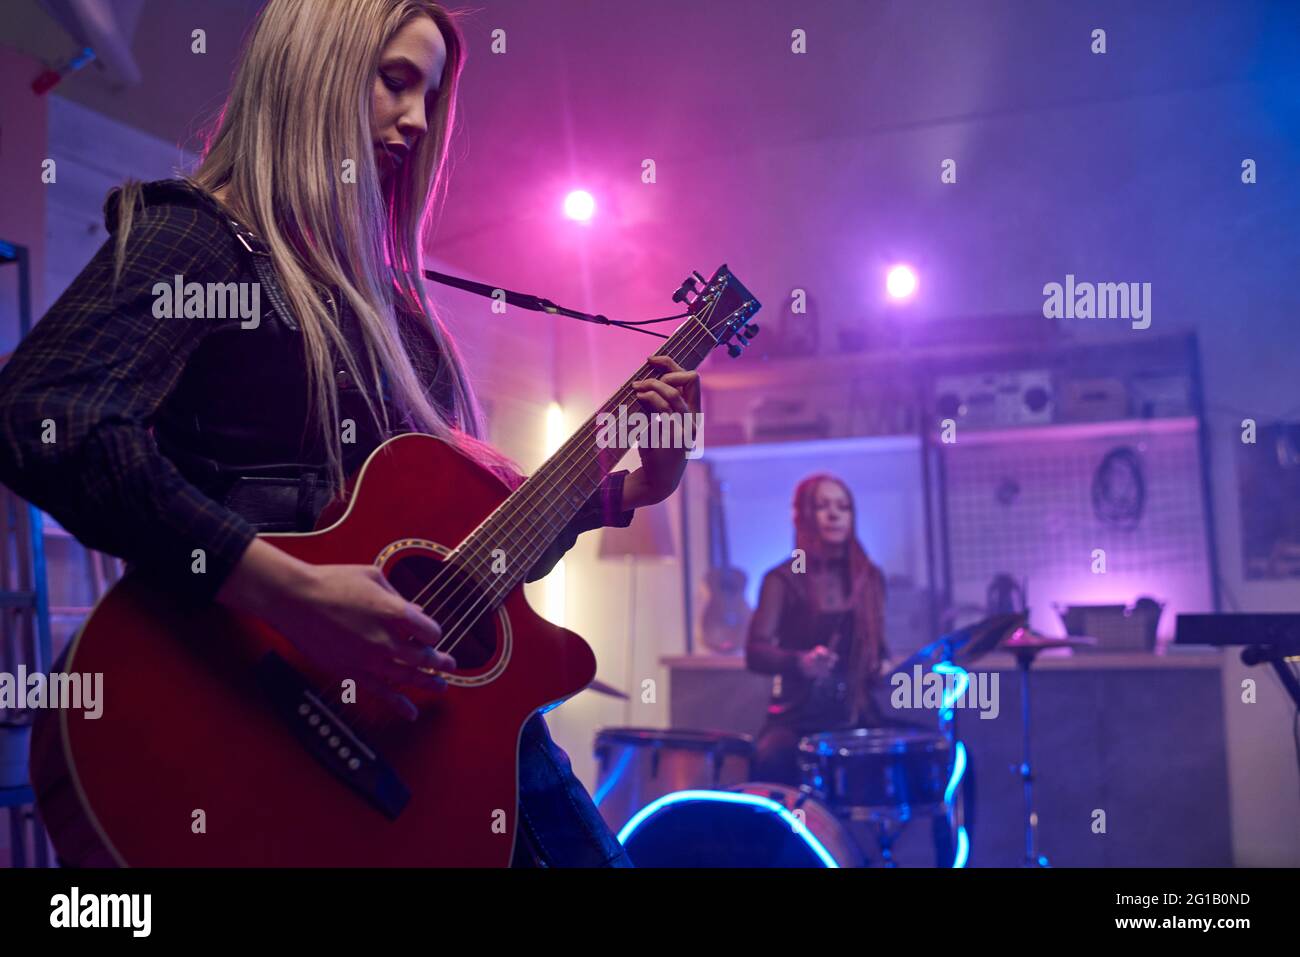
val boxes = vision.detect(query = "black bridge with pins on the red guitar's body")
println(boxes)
[257,651,411,820]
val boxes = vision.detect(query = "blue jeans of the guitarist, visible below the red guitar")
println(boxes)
[511,714,633,867]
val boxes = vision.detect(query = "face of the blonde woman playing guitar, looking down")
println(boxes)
[371,17,447,183]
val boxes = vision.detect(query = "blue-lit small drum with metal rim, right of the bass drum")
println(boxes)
[800,728,953,820]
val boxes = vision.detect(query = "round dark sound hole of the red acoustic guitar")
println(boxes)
[385,553,498,671]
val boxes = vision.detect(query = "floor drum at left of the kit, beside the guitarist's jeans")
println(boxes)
[592,728,754,833]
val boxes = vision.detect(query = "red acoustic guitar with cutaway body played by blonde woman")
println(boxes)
[31,265,759,866]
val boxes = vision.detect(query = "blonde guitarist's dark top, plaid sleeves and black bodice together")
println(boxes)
[0,179,632,601]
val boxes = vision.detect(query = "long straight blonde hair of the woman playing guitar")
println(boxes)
[117,0,520,488]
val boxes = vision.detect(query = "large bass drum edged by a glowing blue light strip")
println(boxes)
[619,783,866,867]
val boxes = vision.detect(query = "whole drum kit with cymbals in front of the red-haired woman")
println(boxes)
[593,614,1091,867]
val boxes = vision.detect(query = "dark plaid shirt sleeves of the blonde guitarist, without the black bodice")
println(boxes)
[0,181,632,601]
